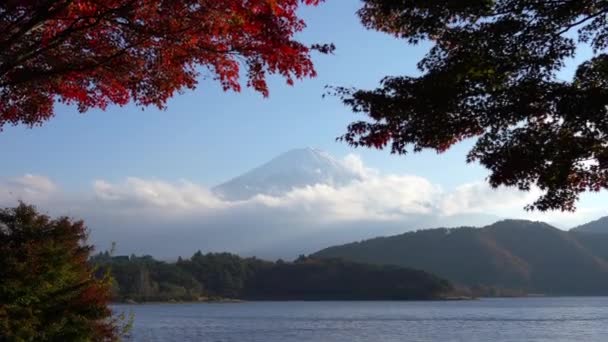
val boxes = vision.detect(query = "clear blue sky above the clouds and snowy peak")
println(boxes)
[0,0,606,232]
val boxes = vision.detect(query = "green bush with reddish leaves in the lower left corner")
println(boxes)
[0,204,121,341]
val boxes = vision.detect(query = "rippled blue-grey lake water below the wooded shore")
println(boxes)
[114,297,608,342]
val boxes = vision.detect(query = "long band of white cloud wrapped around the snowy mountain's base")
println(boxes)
[0,155,599,257]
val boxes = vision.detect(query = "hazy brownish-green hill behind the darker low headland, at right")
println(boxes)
[313,220,608,295]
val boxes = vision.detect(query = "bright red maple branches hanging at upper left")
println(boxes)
[0,0,333,129]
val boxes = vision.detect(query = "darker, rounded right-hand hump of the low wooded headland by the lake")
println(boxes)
[243,258,450,300]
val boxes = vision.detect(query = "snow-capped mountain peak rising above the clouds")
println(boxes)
[212,148,361,201]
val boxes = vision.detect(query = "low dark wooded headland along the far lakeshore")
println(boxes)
[91,252,451,301]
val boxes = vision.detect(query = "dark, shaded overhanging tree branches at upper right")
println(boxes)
[336,0,608,210]
